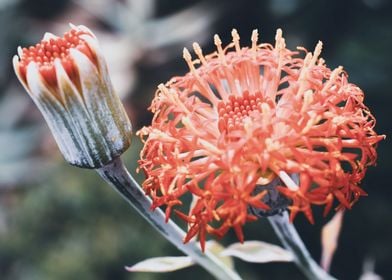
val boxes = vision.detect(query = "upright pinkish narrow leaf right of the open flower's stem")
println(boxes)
[321,211,344,272]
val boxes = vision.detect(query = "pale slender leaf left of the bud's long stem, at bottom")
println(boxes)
[125,257,194,272]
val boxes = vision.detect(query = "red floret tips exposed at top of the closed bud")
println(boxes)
[19,29,94,85]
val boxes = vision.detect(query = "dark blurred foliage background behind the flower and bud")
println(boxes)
[0,0,392,280]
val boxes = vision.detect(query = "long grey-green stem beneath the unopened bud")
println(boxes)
[97,157,241,280]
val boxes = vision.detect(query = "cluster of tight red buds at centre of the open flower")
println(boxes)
[218,91,263,132]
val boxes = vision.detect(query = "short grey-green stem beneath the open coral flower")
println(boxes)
[268,211,336,280]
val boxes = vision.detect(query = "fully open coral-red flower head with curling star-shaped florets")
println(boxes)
[138,29,384,250]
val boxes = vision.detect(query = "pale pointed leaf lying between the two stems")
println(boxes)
[221,241,294,263]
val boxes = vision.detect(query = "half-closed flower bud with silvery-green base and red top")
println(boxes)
[13,25,132,168]
